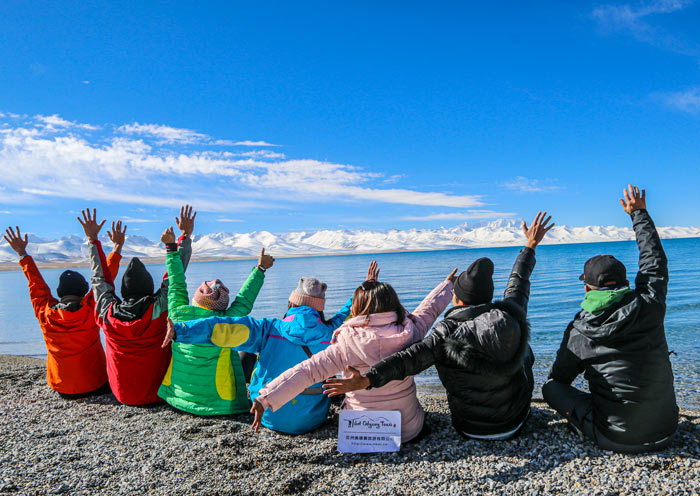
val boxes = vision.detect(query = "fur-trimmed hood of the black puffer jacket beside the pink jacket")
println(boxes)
[440,301,530,375]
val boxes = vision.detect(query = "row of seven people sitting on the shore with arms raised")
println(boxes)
[5,185,678,453]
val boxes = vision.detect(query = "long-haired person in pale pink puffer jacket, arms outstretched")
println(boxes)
[251,262,457,443]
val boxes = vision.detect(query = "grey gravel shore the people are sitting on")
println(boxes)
[0,355,700,496]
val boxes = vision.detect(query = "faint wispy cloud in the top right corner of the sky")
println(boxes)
[591,0,700,56]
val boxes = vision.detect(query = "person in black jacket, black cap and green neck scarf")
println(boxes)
[542,185,678,453]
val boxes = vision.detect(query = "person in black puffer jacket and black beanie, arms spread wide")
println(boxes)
[324,212,554,439]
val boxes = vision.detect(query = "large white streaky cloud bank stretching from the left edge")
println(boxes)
[0,112,484,212]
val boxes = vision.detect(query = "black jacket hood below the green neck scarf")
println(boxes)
[572,291,642,340]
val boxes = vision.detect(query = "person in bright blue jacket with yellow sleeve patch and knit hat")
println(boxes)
[170,277,352,434]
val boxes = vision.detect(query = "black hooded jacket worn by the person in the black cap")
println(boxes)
[549,210,678,445]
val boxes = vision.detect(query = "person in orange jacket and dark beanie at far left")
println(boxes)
[4,222,126,399]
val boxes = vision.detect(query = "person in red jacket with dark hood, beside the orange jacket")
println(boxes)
[78,206,196,405]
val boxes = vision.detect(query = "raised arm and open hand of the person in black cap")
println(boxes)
[620,184,668,307]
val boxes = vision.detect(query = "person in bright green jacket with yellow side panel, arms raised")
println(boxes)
[158,207,275,415]
